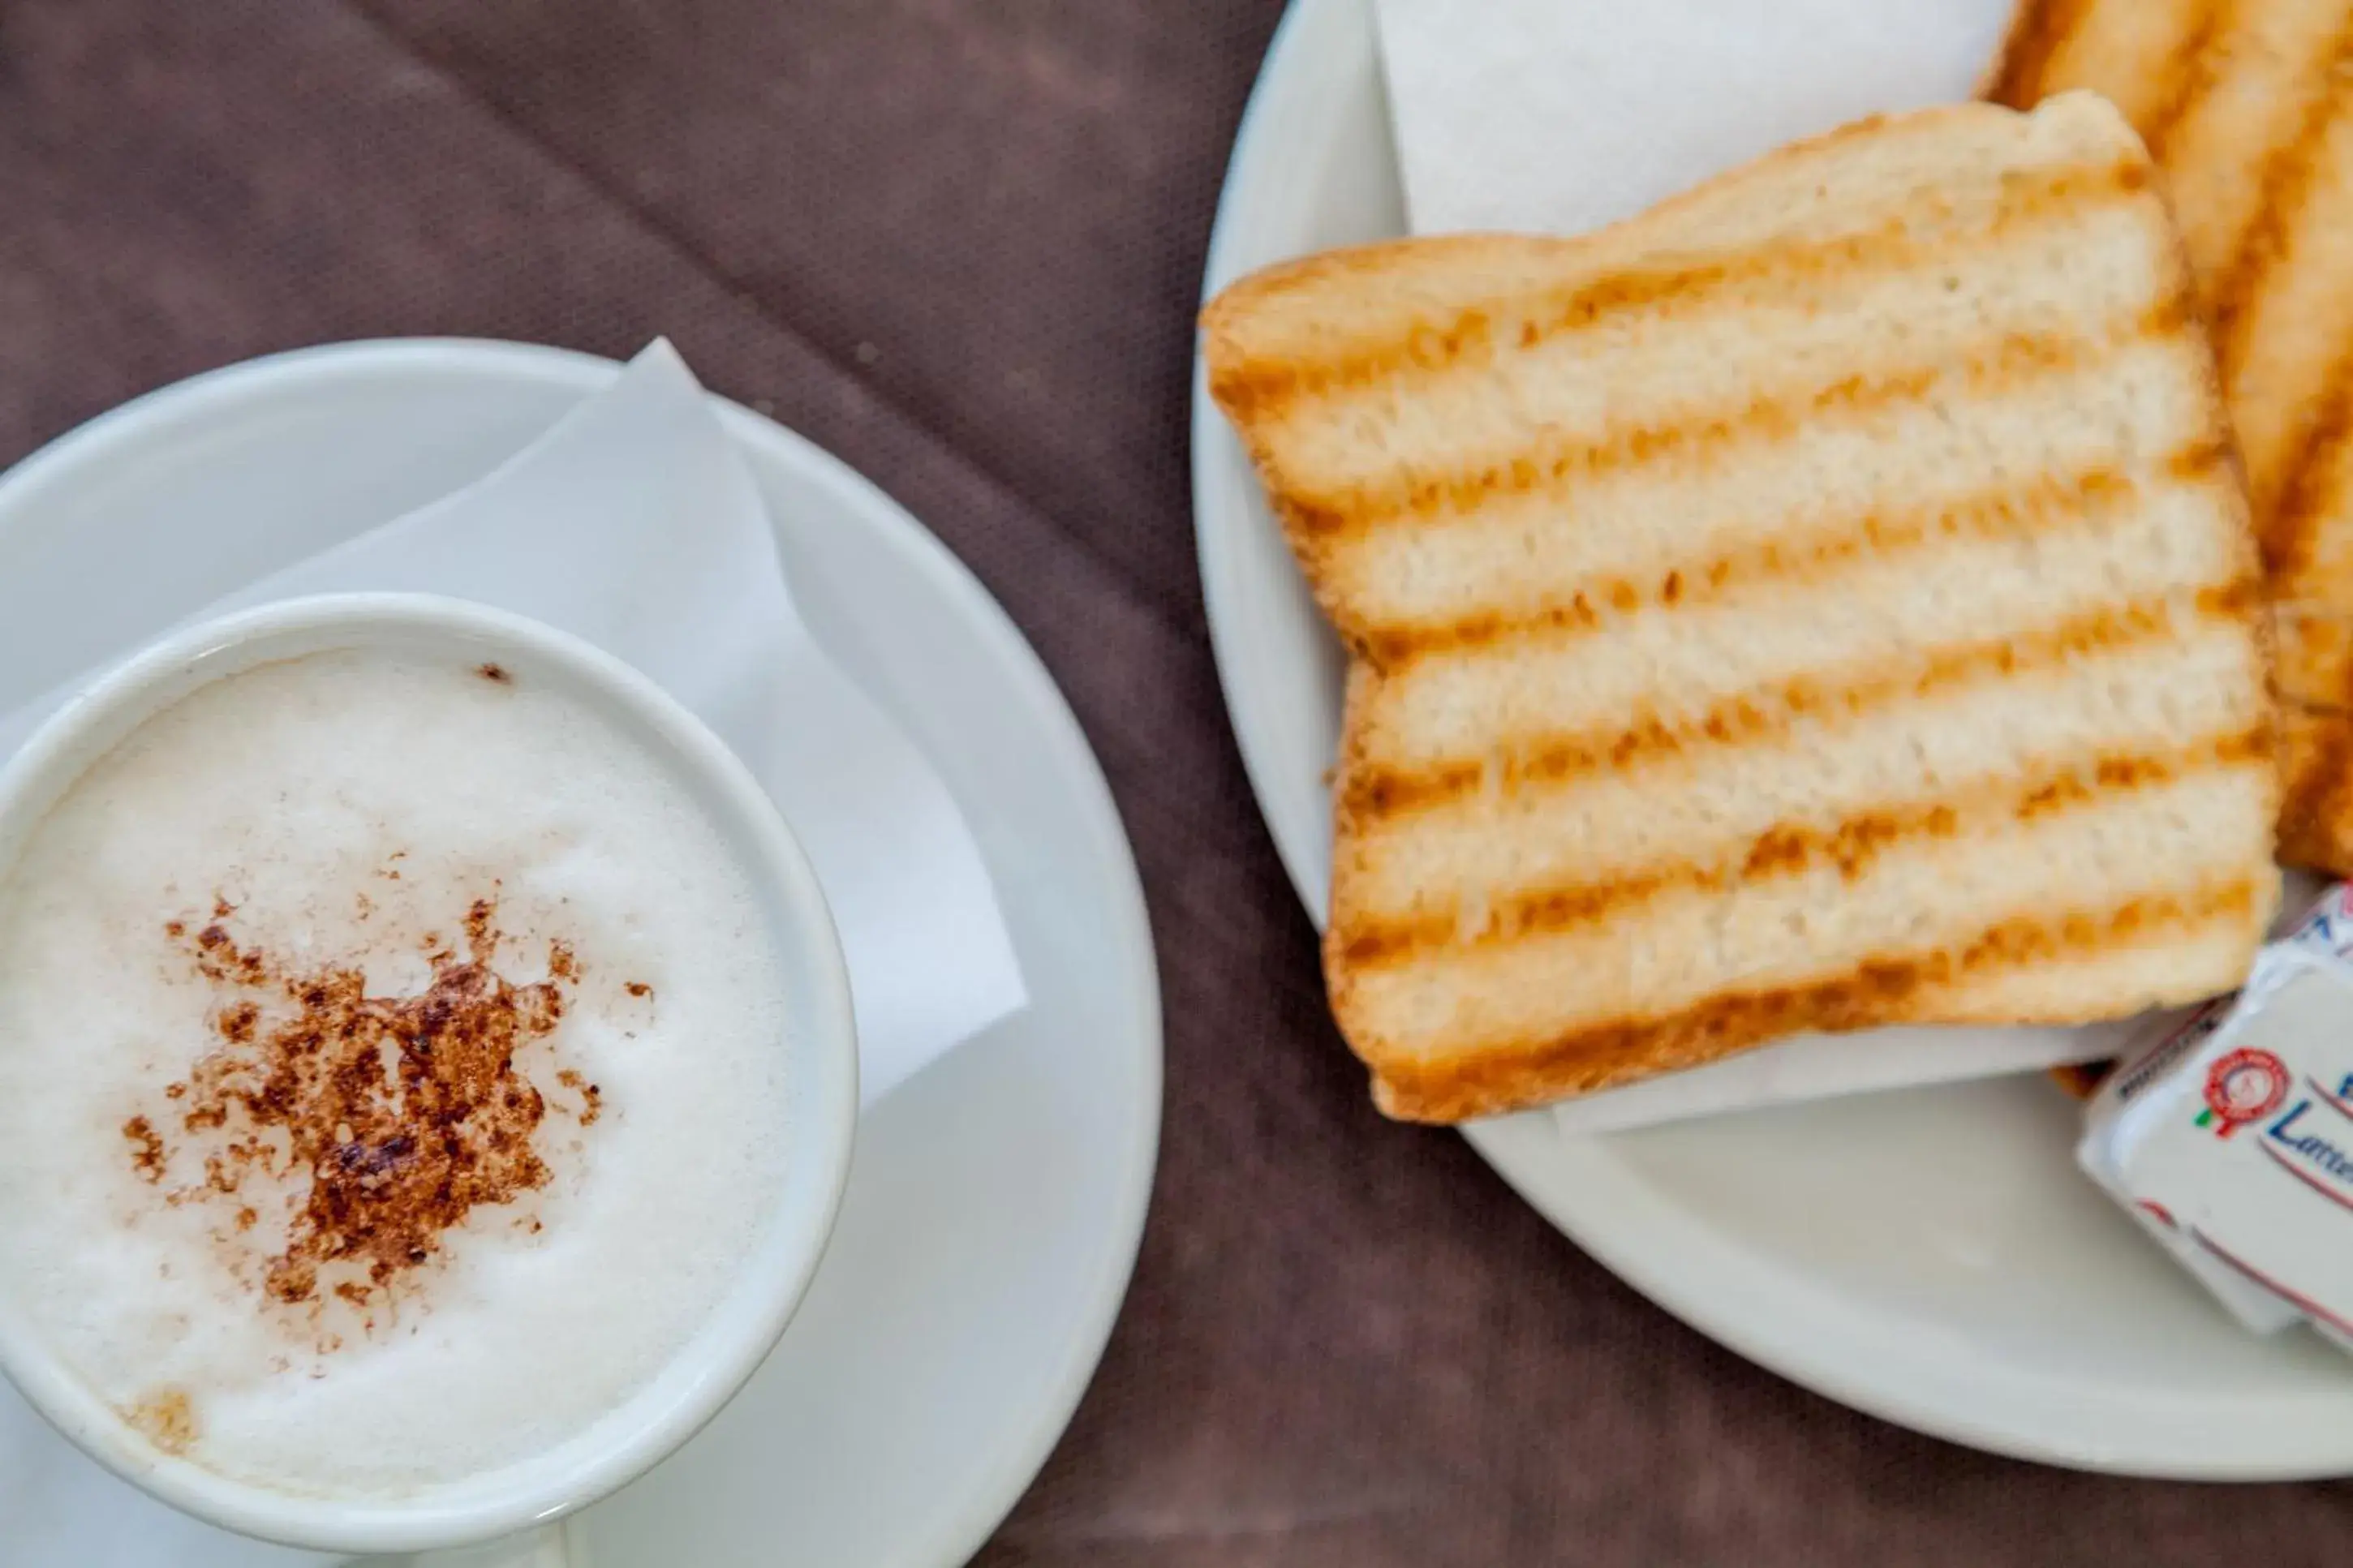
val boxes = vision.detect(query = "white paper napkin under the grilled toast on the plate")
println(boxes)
[1374,0,2134,1133]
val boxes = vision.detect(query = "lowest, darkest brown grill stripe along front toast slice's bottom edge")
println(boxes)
[1374,877,2271,1121]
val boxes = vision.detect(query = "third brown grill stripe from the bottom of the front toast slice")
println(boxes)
[1341,581,2261,820]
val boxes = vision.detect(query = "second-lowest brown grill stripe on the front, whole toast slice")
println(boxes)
[1330,724,2273,969]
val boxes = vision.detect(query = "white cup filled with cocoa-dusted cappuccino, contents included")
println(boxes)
[0,595,857,1554]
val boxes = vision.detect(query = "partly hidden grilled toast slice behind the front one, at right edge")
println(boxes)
[1990,0,2353,874]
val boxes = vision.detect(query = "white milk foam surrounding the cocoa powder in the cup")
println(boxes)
[0,651,789,1495]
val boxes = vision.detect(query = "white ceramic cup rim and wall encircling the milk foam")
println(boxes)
[0,595,857,1563]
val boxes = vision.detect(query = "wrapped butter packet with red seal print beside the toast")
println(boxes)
[2076,884,2353,1349]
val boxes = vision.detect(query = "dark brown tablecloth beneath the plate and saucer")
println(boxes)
[0,0,2353,1568]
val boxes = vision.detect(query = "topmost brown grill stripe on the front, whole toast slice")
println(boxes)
[1212,160,2149,421]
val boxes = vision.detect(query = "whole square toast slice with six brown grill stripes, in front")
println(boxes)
[1202,94,2278,1121]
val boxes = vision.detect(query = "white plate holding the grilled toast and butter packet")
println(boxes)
[1193,0,2353,1479]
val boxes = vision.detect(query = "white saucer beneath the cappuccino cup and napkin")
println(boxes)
[0,341,1160,1568]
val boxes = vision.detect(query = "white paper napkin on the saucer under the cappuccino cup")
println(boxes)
[0,343,1026,1568]
